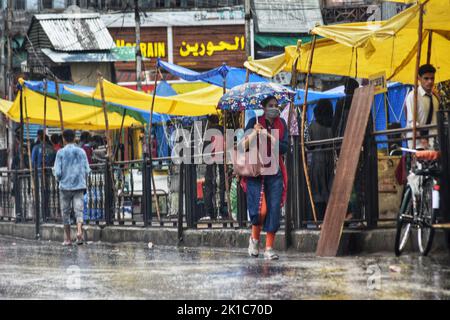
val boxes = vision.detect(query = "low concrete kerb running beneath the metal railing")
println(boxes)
[0,222,447,255]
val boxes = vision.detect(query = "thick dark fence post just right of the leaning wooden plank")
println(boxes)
[362,121,379,228]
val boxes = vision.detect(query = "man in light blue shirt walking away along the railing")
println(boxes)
[53,129,90,245]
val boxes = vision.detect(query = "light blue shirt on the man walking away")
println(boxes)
[53,143,91,190]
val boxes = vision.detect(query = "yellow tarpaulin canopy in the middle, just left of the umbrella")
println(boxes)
[66,80,223,117]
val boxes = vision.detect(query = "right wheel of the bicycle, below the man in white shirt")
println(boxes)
[417,179,436,256]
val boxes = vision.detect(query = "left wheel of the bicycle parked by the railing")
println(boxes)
[395,186,413,257]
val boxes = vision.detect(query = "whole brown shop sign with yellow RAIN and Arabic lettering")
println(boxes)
[109,24,246,71]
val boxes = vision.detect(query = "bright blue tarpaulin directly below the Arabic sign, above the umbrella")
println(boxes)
[158,60,268,89]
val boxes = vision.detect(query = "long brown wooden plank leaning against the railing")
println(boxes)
[316,85,374,256]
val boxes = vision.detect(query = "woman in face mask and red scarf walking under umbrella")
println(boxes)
[241,96,289,260]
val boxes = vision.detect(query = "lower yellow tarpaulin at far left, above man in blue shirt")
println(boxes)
[0,86,142,130]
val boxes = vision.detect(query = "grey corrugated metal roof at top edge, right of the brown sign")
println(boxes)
[252,0,323,33]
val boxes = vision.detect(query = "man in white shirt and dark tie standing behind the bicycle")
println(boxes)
[406,64,439,149]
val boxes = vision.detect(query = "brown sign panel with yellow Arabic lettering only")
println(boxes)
[173,25,246,70]
